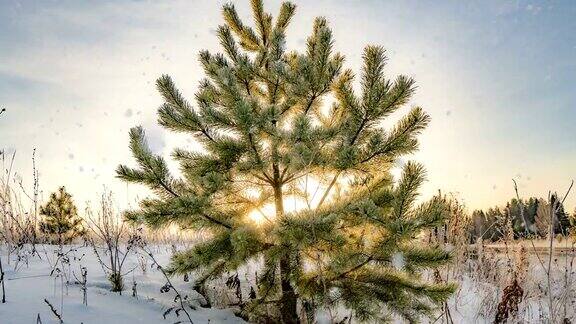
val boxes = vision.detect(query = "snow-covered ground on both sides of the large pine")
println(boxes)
[0,245,576,324]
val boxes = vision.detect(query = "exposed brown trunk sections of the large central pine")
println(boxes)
[273,164,299,324]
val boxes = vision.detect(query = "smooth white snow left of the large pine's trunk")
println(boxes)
[0,246,243,324]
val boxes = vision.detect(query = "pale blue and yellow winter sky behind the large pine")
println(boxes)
[0,0,576,210]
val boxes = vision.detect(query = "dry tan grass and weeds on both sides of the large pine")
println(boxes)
[0,151,576,323]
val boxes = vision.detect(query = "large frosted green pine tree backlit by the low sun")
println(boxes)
[117,0,454,323]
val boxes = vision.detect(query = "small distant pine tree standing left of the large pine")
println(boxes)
[40,187,84,245]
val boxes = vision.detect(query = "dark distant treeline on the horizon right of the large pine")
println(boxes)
[469,195,576,242]
